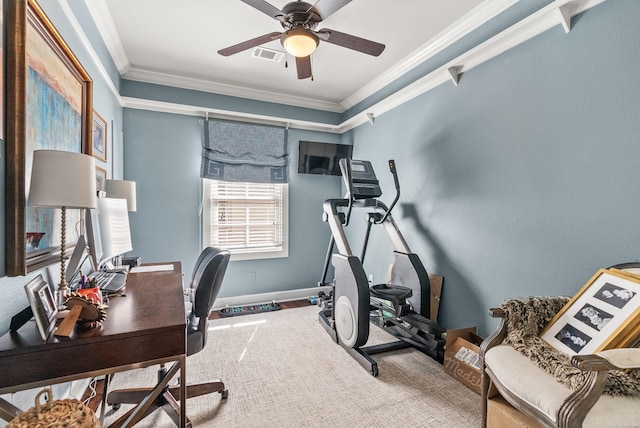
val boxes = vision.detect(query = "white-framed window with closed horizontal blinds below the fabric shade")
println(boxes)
[202,179,289,260]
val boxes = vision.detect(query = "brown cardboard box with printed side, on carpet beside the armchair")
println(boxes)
[444,327,497,397]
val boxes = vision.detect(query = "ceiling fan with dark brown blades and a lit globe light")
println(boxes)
[218,0,385,79]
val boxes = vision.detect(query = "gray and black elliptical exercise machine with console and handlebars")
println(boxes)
[318,158,445,376]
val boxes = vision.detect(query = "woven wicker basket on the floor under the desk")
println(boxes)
[7,388,100,428]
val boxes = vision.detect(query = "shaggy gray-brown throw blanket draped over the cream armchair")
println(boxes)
[500,297,640,396]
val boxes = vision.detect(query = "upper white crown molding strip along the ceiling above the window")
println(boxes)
[123,68,342,113]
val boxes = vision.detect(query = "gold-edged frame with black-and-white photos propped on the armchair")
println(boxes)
[541,269,640,356]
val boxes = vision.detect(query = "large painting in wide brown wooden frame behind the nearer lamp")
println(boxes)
[5,0,93,276]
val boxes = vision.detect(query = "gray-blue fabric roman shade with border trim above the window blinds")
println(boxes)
[200,120,289,183]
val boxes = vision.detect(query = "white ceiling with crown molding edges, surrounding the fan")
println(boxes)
[87,0,490,111]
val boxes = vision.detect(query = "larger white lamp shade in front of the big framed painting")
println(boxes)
[29,150,96,208]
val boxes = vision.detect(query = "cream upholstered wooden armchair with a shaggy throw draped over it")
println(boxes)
[480,297,640,428]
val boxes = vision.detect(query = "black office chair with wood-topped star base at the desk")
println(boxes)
[107,247,230,426]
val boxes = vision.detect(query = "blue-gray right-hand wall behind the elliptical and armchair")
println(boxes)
[350,1,640,334]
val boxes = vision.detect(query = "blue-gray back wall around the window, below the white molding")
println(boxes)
[124,109,341,297]
